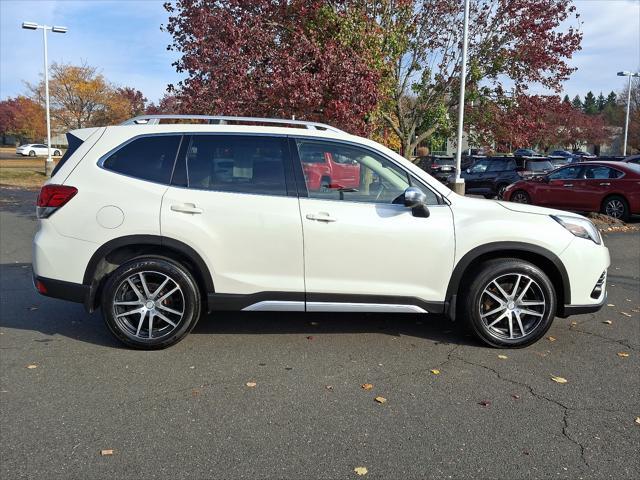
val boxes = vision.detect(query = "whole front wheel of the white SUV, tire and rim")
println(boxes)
[461,258,557,348]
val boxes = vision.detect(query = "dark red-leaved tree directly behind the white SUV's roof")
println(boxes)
[165,0,379,134]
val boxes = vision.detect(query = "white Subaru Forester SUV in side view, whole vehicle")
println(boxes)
[33,115,609,349]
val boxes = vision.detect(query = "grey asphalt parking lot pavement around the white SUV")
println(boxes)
[0,190,640,479]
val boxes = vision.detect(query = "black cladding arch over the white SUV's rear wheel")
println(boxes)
[82,235,215,312]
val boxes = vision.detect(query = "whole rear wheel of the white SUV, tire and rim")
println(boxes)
[101,257,202,350]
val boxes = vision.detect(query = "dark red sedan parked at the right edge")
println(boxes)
[504,162,640,220]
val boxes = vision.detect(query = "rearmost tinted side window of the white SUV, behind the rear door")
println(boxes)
[102,135,182,184]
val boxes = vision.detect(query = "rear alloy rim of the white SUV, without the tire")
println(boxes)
[113,271,185,341]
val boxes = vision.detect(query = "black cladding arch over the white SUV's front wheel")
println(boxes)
[446,242,571,320]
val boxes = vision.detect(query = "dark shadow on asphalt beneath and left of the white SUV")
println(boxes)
[0,263,477,348]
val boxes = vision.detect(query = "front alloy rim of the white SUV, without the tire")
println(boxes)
[478,273,547,340]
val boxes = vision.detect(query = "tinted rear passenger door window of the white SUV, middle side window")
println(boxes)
[186,135,289,196]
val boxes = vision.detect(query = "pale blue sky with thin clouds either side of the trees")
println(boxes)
[0,0,640,101]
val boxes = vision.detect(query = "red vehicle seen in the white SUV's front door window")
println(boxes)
[300,144,360,190]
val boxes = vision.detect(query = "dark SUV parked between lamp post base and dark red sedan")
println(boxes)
[461,157,554,198]
